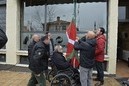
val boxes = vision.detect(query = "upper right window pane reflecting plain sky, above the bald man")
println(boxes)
[77,2,107,32]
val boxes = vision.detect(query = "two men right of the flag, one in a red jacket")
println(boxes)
[74,27,106,86]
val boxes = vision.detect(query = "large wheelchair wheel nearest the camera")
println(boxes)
[51,74,72,86]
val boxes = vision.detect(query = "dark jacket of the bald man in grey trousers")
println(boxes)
[74,39,96,68]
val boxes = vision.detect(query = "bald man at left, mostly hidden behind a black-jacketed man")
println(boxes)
[28,34,40,86]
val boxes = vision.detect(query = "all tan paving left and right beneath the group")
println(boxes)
[0,71,121,86]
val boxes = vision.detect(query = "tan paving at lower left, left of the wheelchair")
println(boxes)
[0,71,50,86]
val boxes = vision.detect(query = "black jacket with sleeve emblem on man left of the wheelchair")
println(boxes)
[29,41,49,74]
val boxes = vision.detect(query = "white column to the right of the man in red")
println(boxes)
[108,0,118,74]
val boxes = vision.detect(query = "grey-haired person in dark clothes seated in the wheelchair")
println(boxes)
[51,45,80,84]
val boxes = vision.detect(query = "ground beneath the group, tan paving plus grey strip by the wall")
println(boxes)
[0,64,121,86]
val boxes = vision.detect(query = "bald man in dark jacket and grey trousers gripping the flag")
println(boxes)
[74,31,96,86]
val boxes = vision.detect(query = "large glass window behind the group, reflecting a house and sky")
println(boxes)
[21,2,107,50]
